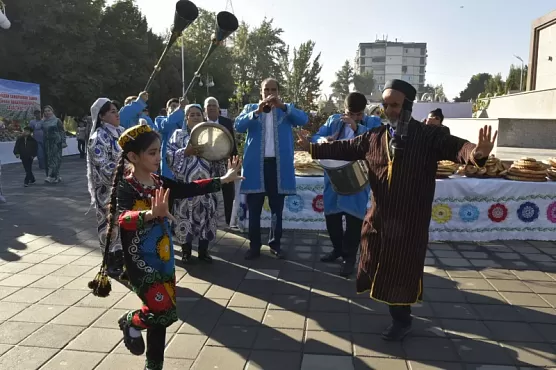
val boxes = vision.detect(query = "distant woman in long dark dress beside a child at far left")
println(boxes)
[42,105,67,184]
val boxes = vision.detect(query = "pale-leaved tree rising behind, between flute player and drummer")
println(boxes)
[281,40,322,110]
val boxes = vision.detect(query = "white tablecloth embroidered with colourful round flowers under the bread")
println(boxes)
[232,177,556,241]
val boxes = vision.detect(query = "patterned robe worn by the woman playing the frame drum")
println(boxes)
[166,130,226,248]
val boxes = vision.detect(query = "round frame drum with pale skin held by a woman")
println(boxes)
[189,122,234,161]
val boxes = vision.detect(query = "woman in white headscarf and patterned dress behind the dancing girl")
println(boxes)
[87,98,124,277]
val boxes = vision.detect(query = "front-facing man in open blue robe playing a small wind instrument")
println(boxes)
[235,78,309,260]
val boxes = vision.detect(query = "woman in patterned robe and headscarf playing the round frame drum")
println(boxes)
[166,104,226,263]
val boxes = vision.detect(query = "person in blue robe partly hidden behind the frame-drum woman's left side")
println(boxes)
[154,98,187,180]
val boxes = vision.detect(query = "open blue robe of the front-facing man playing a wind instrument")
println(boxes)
[235,104,309,194]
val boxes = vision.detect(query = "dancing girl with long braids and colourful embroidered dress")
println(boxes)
[89,125,241,370]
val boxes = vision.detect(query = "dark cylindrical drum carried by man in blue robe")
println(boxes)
[317,159,369,195]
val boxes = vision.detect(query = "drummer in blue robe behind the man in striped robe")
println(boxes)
[311,92,381,277]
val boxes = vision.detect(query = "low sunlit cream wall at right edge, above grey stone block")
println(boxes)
[487,88,556,119]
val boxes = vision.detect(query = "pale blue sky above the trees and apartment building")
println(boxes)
[127,0,556,98]
